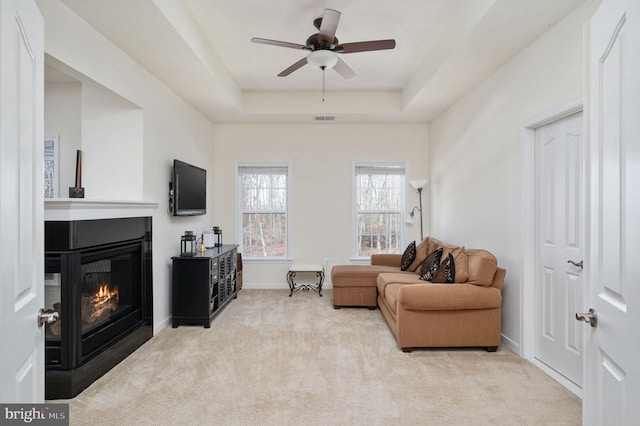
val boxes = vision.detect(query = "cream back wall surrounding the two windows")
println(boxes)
[213,123,428,288]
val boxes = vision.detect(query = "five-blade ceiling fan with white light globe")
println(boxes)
[251,9,396,78]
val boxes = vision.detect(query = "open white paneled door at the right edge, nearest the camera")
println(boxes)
[582,0,640,425]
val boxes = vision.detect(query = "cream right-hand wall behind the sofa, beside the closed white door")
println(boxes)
[430,1,599,353]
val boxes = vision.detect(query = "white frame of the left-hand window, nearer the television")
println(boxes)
[235,161,291,262]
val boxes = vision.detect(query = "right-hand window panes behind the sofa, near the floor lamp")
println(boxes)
[354,162,405,257]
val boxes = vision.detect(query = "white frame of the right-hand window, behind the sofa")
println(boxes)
[351,161,407,262]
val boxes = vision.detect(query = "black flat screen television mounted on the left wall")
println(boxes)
[173,160,207,216]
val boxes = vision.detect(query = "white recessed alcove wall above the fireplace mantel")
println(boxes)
[45,78,143,200]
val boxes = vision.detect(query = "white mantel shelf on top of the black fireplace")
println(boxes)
[44,198,159,221]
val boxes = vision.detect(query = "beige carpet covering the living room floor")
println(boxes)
[58,289,581,425]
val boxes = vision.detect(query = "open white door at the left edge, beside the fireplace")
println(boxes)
[0,0,44,403]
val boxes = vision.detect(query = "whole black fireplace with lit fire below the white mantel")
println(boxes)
[45,217,153,399]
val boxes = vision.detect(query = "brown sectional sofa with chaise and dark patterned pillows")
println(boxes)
[331,237,506,352]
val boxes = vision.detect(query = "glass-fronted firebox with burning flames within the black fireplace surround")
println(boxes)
[45,242,144,368]
